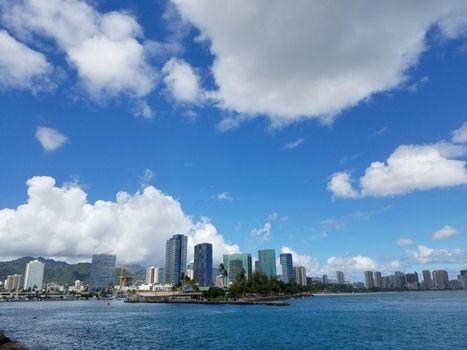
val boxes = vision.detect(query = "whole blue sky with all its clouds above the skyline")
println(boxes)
[0,0,467,280]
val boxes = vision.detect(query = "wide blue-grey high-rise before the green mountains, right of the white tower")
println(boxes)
[89,254,117,289]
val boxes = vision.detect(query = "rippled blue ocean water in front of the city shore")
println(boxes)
[0,291,467,350]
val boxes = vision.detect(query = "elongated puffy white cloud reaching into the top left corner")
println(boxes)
[2,0,157,100]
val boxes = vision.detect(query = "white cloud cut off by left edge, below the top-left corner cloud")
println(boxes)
[0,30,53,91]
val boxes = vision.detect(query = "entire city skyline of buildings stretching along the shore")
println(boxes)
[0,239,467,293]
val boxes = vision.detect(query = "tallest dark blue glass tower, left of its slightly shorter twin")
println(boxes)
[164,235,188,284]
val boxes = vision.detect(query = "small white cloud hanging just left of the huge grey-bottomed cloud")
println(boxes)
[162,58,202,103]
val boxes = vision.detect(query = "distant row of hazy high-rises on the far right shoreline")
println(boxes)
[363,270,467,290]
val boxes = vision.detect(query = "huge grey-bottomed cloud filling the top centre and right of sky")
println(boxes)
[172,0,467,126]
